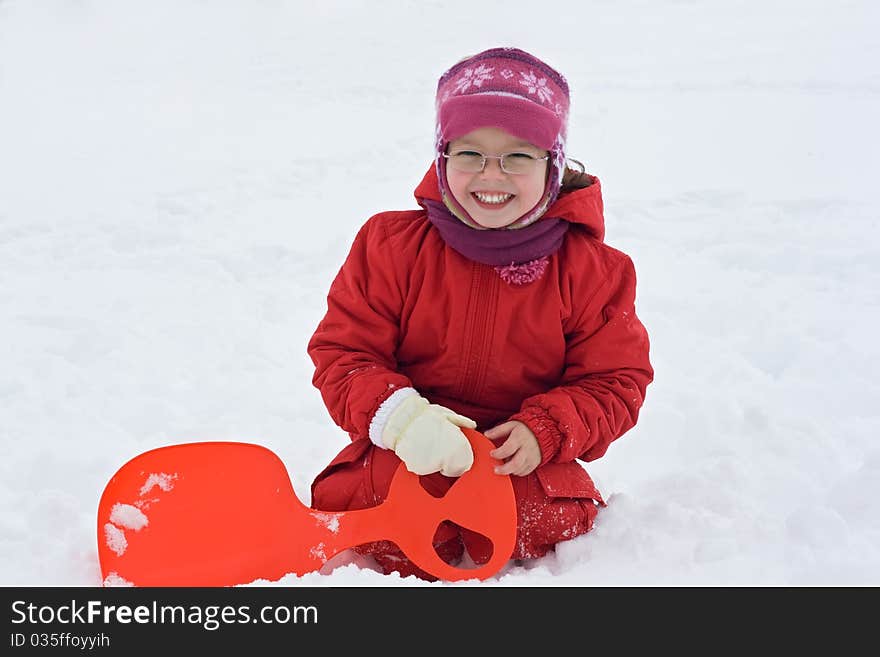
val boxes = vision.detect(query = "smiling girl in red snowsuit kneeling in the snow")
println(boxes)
[308,48,653,579]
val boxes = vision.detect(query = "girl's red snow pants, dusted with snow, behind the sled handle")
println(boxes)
[311,438,605,581]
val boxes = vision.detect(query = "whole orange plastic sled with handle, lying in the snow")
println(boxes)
[98,429,516,586]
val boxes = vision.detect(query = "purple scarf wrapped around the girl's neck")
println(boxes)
[421,199,569,270]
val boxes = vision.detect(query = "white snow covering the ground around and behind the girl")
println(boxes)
[0,0,880,587]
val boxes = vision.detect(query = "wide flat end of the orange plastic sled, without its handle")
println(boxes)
[98,442,308,586]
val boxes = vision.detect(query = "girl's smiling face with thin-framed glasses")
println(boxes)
[446,127,547,228]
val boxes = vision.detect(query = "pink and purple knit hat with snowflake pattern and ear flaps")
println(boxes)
[435,48,569,228]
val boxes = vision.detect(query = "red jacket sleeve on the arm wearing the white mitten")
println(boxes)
[307,216,412,440]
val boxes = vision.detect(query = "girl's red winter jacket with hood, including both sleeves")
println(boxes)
[308,167,653,465]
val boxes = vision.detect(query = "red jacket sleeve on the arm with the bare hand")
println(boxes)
[511,255,654,465]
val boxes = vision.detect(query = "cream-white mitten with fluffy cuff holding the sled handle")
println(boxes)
[382,395,477,477]
